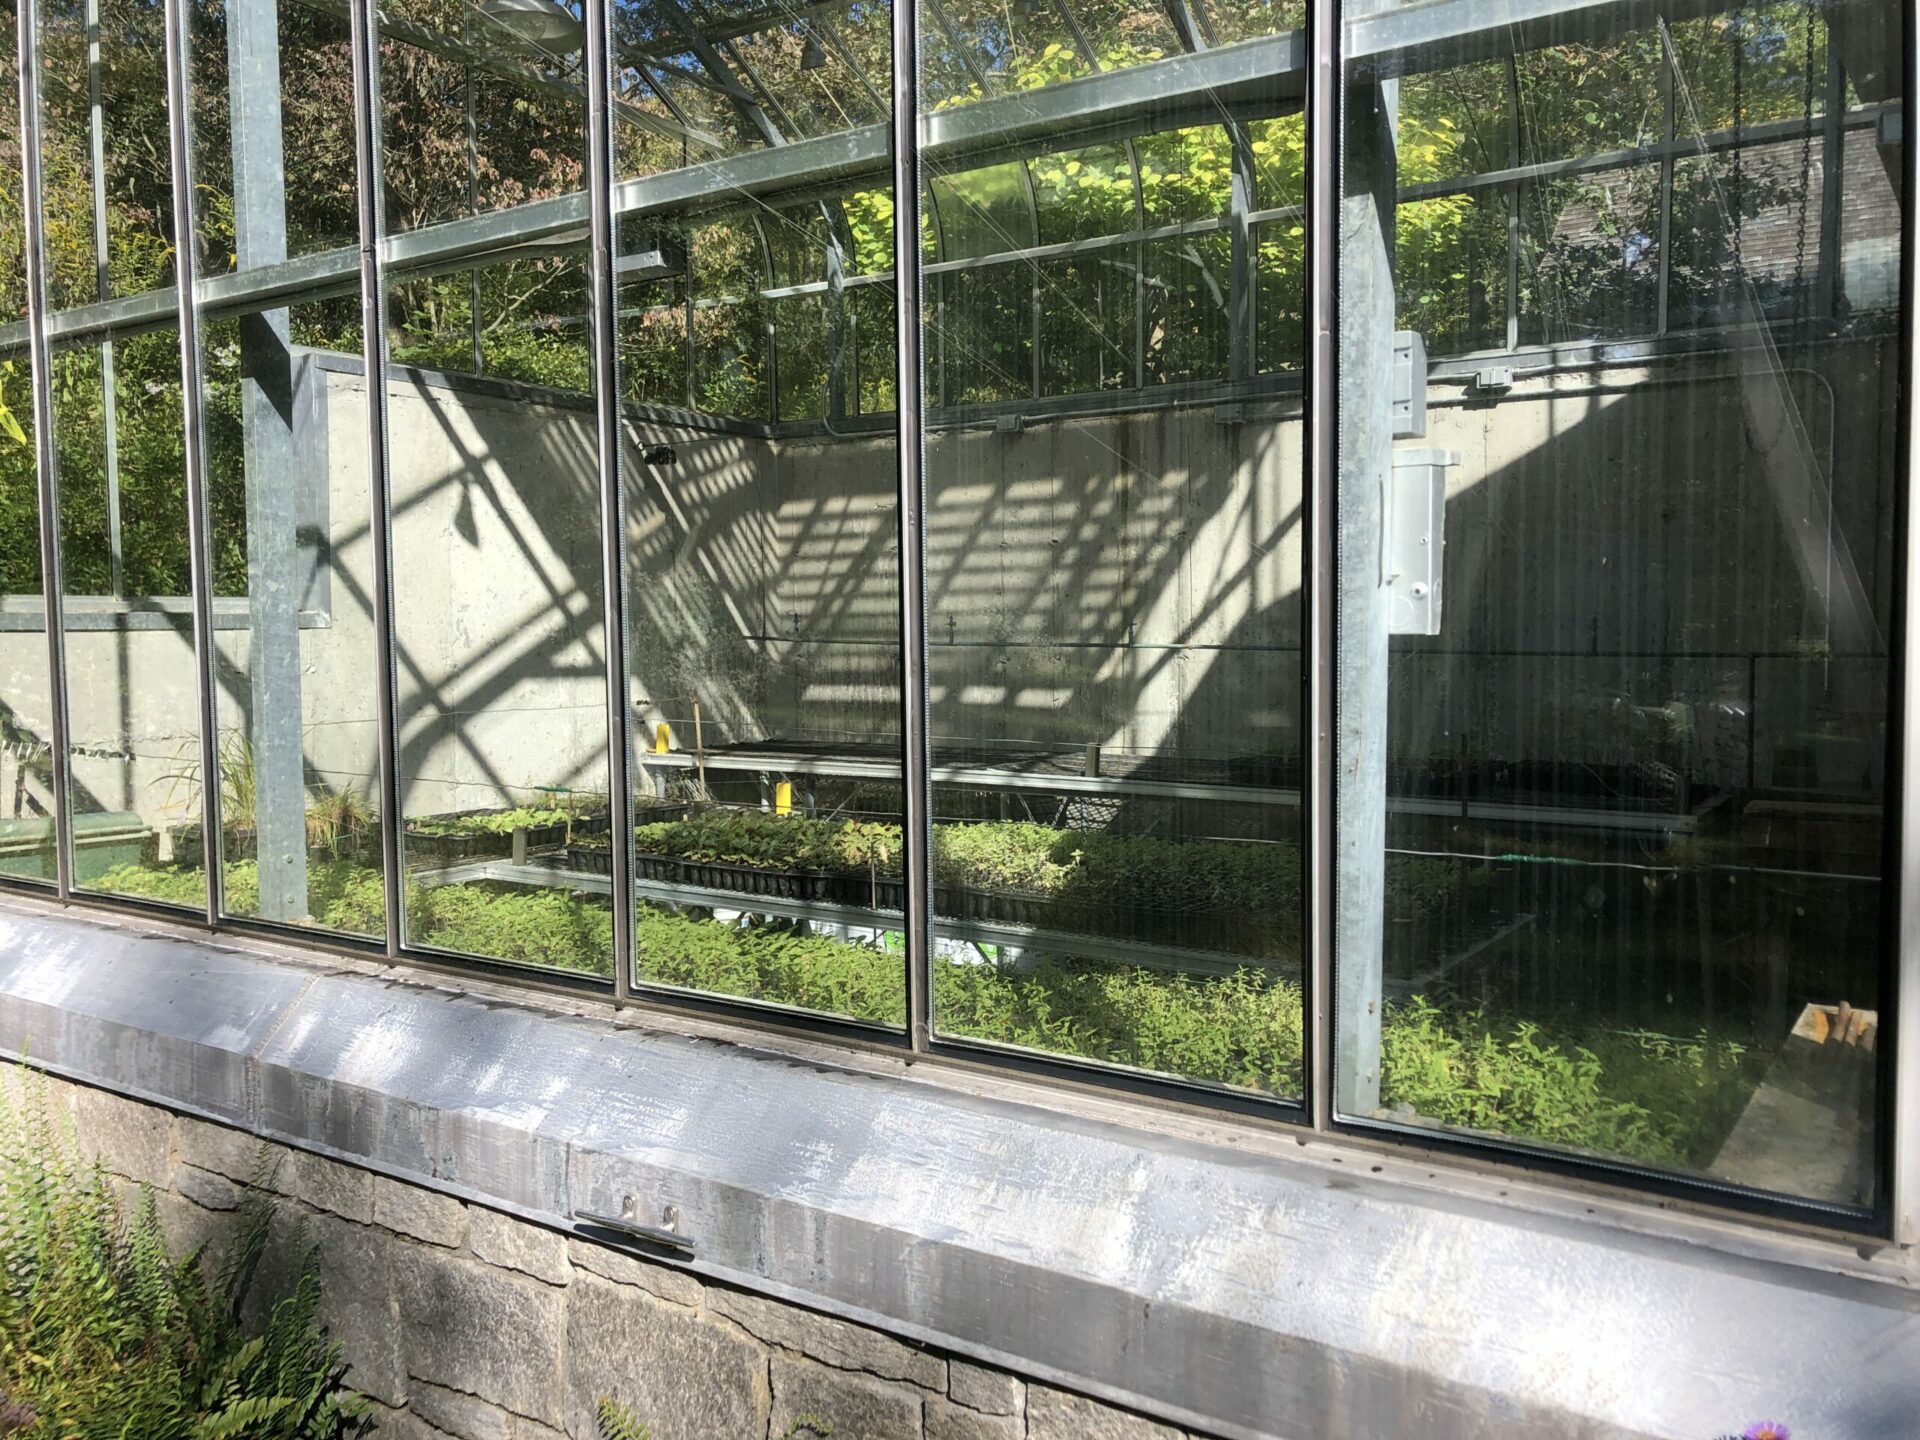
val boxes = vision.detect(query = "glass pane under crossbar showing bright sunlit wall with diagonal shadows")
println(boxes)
[386,252,612,975]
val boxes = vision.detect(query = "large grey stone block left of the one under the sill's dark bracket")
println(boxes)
[393,1229,563,1425]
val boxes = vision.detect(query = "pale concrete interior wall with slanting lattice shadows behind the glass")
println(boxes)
[0,340,1897,826]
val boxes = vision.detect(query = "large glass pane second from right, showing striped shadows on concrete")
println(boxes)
[924,0,1304,1096]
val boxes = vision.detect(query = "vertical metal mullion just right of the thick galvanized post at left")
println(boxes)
[348,0,407,956]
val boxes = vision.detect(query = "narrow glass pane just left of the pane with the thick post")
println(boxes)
[40,0,206,910]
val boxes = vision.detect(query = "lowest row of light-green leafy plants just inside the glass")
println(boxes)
[102,864,1757,1165]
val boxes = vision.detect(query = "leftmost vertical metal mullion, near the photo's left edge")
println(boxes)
[13,0,73,900]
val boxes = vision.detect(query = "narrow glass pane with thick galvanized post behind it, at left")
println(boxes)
[188,0,384,935]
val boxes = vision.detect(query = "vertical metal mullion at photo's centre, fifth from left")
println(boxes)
[893,0,933,1050]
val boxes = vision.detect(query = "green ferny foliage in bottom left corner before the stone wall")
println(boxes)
[0,1075,371,1440]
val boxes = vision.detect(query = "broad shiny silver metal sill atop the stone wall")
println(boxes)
[0,899,1920,1440]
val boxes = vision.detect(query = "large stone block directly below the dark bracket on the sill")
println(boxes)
[560,1271,772,1440]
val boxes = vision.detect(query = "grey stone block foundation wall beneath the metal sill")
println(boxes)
[33,1079,1213,1440]
